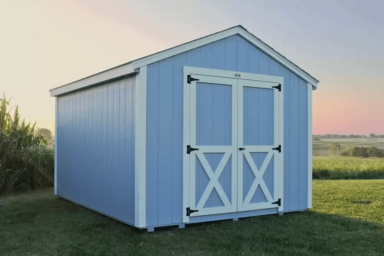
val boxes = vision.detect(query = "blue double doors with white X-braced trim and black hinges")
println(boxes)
[183,69,283,222]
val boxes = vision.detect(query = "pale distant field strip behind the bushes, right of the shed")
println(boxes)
[313,138,384,156]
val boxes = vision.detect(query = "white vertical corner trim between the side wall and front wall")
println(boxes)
[135,66,147,228]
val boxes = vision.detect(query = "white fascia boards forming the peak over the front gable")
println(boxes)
[133,27,319,89]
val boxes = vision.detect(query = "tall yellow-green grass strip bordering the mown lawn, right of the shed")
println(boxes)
[313,156,384,179]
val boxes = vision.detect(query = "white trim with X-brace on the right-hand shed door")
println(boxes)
[237,78,284,212]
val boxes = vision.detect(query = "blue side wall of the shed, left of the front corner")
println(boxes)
[56,77,135,224]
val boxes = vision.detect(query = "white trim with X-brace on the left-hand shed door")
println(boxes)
[187,75,238,217]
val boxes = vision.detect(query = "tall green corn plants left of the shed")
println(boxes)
[0,95,53,195]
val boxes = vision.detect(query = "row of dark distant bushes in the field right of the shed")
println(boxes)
[329,143,384,157]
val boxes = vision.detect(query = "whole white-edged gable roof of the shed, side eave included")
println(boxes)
[50,25,319,96]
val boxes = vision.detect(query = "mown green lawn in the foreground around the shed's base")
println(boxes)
[0,180,384,255]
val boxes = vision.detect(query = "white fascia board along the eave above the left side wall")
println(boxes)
[50,63,135,97]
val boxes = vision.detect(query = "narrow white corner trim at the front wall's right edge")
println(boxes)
[308,83,312,208]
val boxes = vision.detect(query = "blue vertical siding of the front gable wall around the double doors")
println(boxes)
[146,35,308,226]
